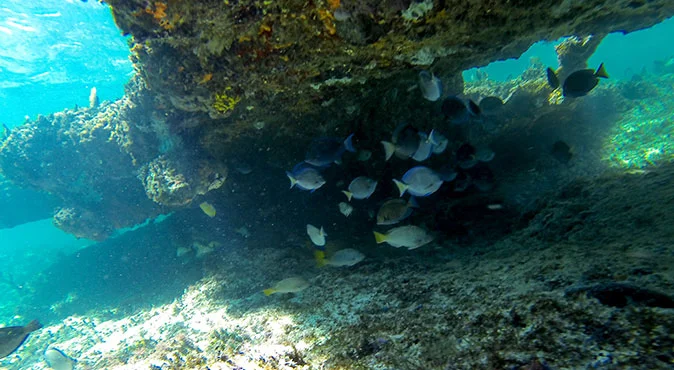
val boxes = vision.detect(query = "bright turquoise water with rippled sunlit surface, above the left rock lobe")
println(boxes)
[0,0,133,127]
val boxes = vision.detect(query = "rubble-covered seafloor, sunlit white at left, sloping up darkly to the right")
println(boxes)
[3,164,674,370]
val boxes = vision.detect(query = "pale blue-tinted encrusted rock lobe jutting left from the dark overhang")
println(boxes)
[0,78,227,240]
